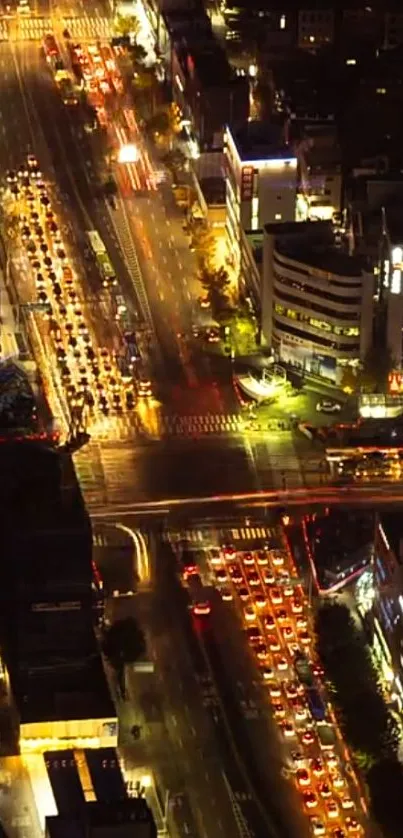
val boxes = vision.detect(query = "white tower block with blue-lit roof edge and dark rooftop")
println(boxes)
[225,121,297,274]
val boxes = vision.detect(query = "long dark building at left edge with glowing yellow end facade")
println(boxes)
[0,441,117,751]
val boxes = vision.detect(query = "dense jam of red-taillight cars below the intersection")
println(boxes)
[181,537,365,838]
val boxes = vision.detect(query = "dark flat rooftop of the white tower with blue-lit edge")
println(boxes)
[228,120,295,161]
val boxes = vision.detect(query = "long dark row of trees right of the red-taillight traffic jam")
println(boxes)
[315,604,398,767]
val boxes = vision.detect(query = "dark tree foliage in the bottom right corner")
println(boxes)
[367,759,403,838]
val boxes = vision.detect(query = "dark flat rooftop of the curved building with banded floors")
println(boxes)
[265,221,365,277]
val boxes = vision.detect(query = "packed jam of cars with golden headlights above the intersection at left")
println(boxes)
[7,154,140,431]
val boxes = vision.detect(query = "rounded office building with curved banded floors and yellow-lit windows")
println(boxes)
[261,221,374,383]
